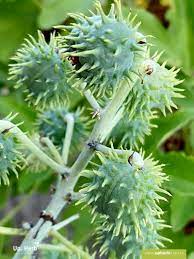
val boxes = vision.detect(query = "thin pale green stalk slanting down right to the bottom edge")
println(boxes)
[50,230,92,259]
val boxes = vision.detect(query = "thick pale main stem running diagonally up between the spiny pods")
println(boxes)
[14,79,136,259]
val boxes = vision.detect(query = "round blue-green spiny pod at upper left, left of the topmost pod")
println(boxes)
[9,32,71,107]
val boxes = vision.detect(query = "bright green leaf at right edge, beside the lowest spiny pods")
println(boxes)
[171,194,194,231]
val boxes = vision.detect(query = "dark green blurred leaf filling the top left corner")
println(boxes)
[0,0,38,63]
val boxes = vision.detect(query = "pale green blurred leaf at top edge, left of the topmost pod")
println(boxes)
[38,0,94,29]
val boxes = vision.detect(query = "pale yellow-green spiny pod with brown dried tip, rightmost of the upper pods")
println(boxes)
[137,55,184,115]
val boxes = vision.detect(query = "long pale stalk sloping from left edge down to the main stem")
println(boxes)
[0,120,68,174]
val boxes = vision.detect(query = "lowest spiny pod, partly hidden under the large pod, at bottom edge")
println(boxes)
[95,217,171,259]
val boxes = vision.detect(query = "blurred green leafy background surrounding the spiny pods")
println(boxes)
[0,0,194,258]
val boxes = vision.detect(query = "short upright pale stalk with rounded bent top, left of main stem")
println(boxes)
[62,113,74,165]
